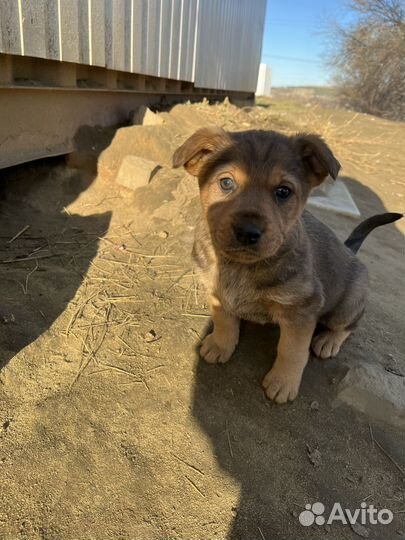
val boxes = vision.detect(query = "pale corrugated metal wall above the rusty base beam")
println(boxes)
[0,0,266,92]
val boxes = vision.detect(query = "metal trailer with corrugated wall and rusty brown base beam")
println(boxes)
[0,0,266,168]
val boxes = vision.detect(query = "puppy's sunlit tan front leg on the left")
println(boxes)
[200,296,240,364]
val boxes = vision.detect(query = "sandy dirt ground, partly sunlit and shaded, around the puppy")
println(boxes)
[0,96,405,540]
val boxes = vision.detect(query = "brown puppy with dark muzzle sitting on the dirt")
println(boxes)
[173,128,401,403]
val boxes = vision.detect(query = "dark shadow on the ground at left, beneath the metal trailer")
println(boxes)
[0,126,115,368]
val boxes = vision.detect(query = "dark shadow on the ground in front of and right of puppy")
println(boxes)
[193,178,404,540]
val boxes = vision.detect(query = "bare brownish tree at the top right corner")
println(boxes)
[329,0,405,120]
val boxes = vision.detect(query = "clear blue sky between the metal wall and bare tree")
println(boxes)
[262,0,345,86]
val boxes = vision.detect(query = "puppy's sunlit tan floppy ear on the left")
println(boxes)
[173,127,232,176]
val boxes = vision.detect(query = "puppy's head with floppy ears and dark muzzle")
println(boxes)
[173,128,340,264]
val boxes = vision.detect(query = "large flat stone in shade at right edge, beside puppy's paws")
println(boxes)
[337,364,405,427]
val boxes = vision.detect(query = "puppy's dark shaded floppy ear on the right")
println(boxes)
[293,133,340,185]
